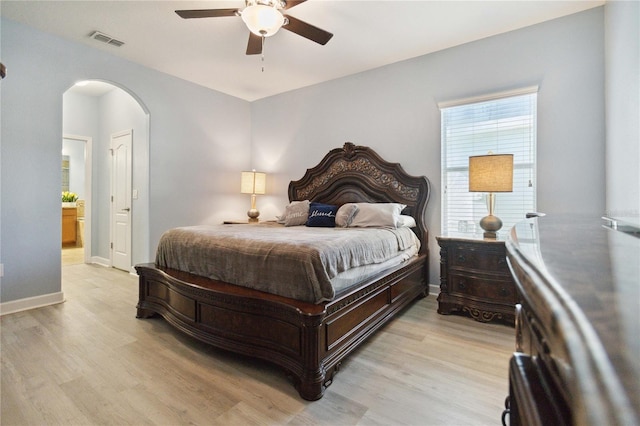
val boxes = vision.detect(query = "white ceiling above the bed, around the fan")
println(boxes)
[0,0,604,101]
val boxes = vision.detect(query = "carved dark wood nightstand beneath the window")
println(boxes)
[436,234,518,325]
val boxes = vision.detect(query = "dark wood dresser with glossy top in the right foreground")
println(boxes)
[503,215,640,426]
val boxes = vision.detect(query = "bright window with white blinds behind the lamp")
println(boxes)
[439,87,537,235]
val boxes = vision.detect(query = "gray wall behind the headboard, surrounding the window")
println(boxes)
[251,8,605,284]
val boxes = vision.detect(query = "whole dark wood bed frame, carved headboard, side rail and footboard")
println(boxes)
[136,142,430,400]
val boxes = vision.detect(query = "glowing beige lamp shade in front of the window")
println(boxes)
[469,154,513,192]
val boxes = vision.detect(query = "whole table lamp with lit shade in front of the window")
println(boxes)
[469,154,513,238]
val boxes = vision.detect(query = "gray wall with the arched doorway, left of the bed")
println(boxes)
[0,19,251,303]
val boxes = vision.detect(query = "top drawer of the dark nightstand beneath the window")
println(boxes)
[449,244,510,276]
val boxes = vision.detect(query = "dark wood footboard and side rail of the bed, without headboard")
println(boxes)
[136,255,428,400]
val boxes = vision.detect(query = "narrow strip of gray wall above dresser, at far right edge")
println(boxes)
[605,0,640,220]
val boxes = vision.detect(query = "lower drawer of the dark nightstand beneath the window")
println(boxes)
[449,273,517,305]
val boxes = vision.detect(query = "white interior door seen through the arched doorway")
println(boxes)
[111,130,133,271]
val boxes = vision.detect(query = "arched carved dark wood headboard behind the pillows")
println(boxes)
[289,142,431,253]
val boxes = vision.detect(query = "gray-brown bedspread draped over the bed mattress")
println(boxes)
[156,223,420,303]
